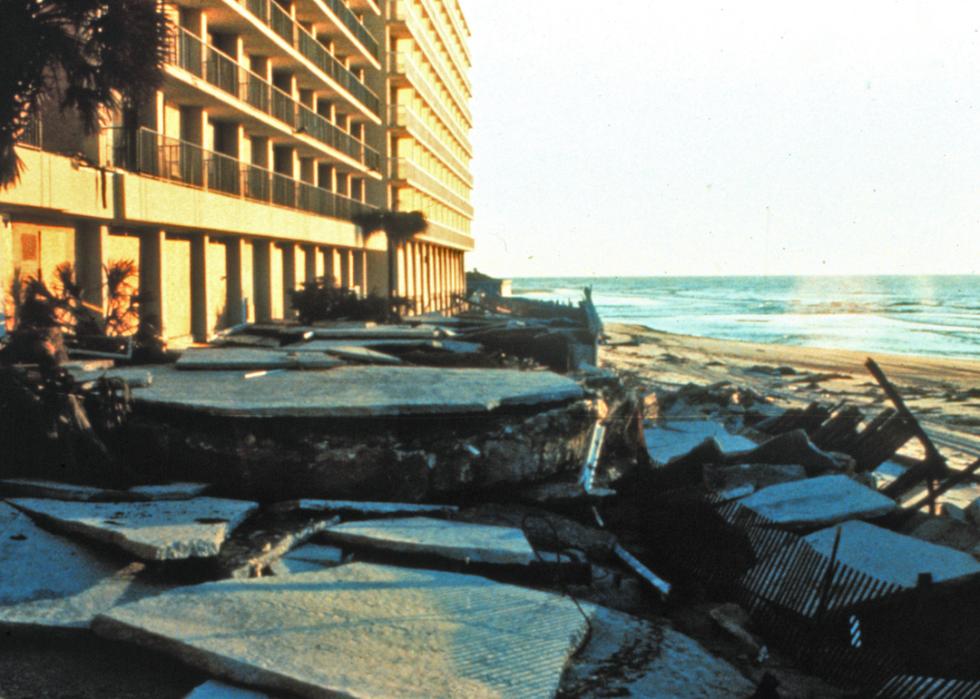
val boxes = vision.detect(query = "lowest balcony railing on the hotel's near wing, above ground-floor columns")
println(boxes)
[110,128,374,219]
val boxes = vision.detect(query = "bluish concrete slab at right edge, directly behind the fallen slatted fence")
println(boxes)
[804,522,980,587]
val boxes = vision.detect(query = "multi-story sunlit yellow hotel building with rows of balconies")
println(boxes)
[0,0,472,344]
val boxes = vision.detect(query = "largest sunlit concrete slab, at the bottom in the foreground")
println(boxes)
[93,563,593,698]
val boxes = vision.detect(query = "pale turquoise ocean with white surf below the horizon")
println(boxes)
[513,275,980,359]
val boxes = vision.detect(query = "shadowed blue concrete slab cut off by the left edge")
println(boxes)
[0,503,166,629]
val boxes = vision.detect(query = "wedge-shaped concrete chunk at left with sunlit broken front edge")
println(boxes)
[9,498,258,561]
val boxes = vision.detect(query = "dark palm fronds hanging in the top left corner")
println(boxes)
[0,0,170,188]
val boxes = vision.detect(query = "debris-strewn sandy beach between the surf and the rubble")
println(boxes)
[600,323,980,468]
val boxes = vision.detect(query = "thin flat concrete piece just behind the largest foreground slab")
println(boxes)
[324,517,535,565]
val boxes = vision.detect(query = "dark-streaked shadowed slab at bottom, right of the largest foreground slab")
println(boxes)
[561,607,754,699]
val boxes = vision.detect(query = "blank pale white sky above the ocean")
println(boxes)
[461,0,980,277]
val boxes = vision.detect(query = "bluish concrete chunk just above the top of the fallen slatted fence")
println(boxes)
[742,474,897,527]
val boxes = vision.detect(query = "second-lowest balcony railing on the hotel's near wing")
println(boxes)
[170,28,381,172]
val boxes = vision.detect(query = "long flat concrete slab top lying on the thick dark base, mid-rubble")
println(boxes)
[127,366,583,418]
